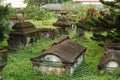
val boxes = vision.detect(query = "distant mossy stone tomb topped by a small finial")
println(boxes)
[53,12,75,34]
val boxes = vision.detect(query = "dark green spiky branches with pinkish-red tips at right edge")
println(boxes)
[79,0,120,42]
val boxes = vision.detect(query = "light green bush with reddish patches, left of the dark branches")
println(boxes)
[70,4,96,30]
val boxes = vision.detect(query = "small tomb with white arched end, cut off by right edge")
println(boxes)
[98,50,120,72]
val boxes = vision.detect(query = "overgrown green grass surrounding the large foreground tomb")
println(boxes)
[3,32,120,80]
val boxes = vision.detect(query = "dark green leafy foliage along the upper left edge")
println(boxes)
[0,5,11,43]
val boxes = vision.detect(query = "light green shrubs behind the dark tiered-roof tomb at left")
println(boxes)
[25,6,56,24]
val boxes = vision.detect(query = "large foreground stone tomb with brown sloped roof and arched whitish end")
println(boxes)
[30,37,86,75]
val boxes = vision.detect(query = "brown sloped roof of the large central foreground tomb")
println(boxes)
[31,38,86,64]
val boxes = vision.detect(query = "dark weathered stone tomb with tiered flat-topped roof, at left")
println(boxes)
[8,22,40,50]
